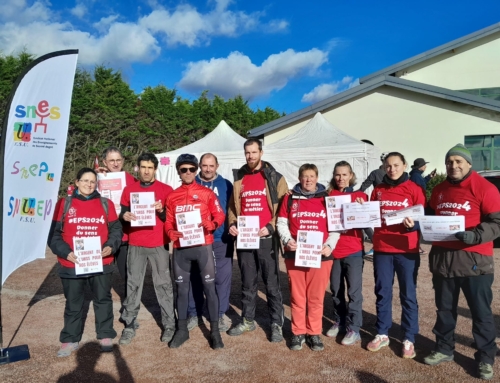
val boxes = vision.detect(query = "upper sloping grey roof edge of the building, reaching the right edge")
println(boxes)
[359,23,500,84]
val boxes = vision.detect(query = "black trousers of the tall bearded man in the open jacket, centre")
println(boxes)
[237,238,283,326]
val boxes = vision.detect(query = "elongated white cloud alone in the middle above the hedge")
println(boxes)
[178,48,328,100]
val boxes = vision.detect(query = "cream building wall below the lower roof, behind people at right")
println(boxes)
[264,87,500,176]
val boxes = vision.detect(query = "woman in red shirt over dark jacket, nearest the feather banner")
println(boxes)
[50,168,122,357]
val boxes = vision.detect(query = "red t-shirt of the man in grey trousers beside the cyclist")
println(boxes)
[120,180,173,248]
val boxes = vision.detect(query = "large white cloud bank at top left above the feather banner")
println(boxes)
[0,0,288,65]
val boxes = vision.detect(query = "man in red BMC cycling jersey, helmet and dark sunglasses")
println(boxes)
[165,154,226,349]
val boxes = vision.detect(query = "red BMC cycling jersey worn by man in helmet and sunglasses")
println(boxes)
[165,182,226,248]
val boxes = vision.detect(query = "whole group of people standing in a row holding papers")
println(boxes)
[49,138,500,379]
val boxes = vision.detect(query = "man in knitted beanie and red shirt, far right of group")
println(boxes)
[424,144,500,380]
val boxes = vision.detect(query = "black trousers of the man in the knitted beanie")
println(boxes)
[432,274,497,365]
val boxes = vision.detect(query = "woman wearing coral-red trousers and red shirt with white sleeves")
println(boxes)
[276,164,339,351]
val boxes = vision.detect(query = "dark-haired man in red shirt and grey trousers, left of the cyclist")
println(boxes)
[120,153,175,344]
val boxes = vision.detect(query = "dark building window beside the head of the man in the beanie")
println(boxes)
[465,135,500,170]
